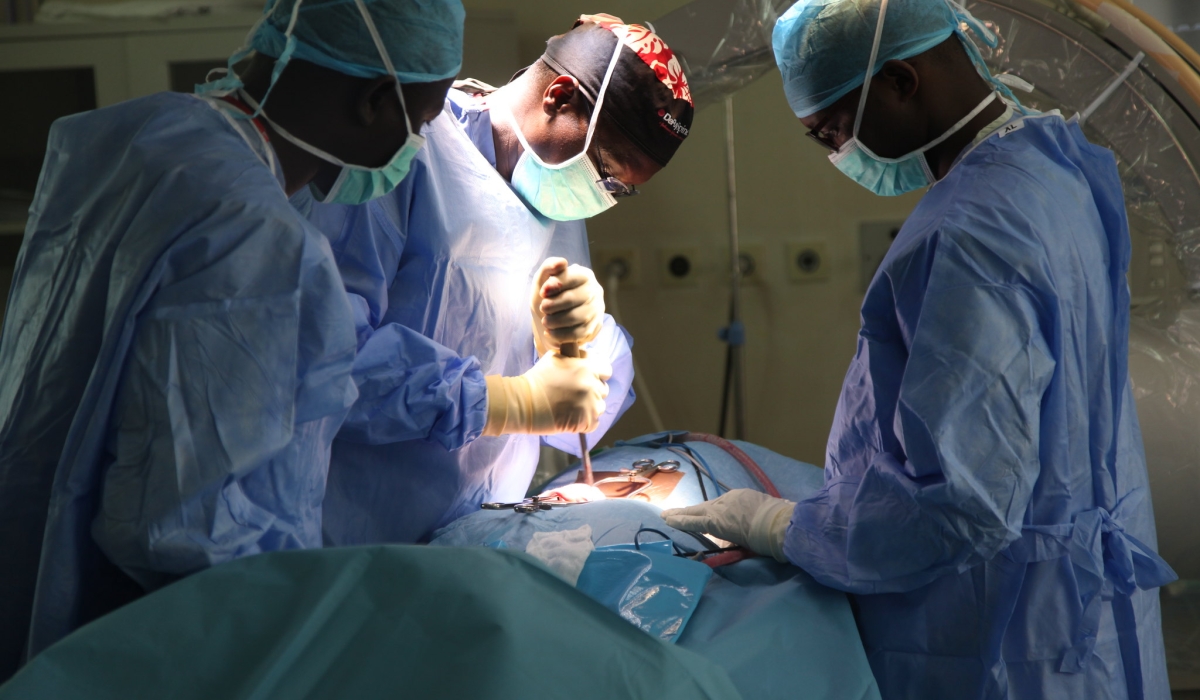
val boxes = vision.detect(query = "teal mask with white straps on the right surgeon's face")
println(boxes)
[829,0,997,197]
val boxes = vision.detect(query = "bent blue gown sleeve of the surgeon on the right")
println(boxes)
[784,226,1055,593]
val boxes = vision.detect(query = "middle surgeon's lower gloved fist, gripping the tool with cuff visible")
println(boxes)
[484,353,612,436]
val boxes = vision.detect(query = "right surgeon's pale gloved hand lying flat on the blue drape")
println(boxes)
[662,489,796,563]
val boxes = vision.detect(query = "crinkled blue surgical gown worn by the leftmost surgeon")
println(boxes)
[0,94,356,678]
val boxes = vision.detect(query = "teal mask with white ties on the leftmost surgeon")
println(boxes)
[201,0,425,204]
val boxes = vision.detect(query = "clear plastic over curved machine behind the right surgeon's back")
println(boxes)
[968,0,1200,579]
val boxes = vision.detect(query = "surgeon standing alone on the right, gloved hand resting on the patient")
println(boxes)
[664,0,1175,700]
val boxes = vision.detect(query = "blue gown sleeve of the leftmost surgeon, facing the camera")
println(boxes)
[92,229,356,590]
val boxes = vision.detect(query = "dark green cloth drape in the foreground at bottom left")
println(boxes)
[0,546,739,700]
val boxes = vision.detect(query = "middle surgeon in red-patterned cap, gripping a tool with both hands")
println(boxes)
[293,16,692,545]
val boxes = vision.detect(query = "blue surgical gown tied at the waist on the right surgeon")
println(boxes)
[785,114,1175,700]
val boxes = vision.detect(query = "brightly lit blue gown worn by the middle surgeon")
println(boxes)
[293,90,634,545]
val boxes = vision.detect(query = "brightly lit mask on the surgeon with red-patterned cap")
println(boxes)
[497,35,622,221]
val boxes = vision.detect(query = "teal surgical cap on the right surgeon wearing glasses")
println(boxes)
[772,0,1012,118]
